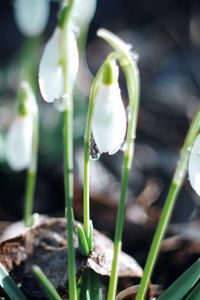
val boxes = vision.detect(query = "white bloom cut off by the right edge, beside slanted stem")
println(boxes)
[188,134,200,196]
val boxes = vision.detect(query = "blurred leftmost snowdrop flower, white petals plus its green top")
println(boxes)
[6,82,37,171]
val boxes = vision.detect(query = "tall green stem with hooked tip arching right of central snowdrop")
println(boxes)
[98,29,139,300]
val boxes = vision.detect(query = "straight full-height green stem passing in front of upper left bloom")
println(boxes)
[61,0,77,300]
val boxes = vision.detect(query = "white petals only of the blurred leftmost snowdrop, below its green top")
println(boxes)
[6,115,33,171]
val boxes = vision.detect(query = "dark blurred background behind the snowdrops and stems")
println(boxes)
[0,0,200,285]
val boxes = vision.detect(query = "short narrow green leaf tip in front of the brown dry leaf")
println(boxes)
[33,266,62,300]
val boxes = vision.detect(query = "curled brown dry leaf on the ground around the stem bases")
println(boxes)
[0,218,142,299]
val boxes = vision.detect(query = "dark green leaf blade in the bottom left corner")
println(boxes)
[0,263,27,300]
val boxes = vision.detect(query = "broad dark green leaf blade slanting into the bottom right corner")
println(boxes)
[158,259,200,300]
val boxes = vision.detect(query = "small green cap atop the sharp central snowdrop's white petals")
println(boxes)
[102,60,119,85]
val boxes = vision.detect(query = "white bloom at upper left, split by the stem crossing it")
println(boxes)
[39,28,79,102]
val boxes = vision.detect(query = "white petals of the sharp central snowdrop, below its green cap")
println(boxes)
[92,82,126,154]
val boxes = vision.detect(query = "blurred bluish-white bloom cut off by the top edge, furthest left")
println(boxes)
[14,0,50,37]
